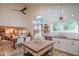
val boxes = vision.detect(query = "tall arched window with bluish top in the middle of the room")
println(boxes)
[32,16,43,35]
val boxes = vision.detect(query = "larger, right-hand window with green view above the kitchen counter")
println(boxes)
[64,20,78,32]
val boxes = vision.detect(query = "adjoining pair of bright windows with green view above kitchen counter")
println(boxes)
[50,20,78,33]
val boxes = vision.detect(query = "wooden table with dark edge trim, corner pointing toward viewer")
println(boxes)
[22,40,54,56]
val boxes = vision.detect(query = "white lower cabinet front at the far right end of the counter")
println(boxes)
[68,40,79,55]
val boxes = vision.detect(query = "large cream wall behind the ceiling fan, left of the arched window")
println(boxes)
[0,3,30,30]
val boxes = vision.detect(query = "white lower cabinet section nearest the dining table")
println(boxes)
[53,38,67,51]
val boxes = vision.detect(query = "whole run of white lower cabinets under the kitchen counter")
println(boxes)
[53,38,79,55]
